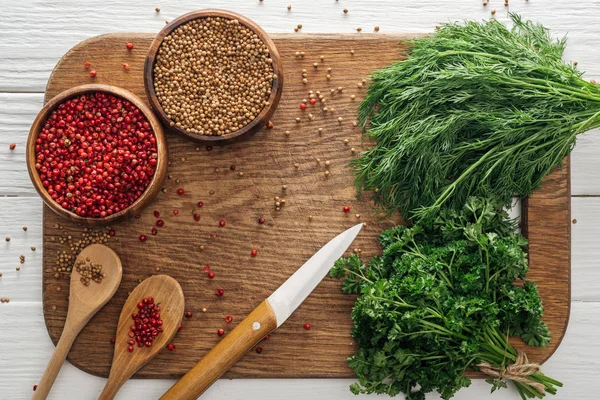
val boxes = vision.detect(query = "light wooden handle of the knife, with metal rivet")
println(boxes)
[160,300,277,400]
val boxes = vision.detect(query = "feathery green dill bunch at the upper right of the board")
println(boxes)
[352,14,600,221]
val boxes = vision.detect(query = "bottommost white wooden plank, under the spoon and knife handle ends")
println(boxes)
[0,302,600,400]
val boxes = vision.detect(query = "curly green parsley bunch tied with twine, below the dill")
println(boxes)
[331,198,562,400]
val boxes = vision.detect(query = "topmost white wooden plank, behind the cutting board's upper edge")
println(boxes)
[0,0,600,92]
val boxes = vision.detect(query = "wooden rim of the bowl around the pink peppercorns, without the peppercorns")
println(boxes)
[27,84,168,225]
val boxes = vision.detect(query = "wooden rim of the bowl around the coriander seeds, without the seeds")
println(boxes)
[144,9,283,143]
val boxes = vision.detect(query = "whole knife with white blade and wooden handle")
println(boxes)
[160,224,363,400]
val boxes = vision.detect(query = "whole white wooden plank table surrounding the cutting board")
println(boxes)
[0,0,600,400]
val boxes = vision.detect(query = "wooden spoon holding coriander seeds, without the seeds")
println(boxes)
[33,244,123,400]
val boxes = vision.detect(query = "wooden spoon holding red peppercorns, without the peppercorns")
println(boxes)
[98,275,184,400]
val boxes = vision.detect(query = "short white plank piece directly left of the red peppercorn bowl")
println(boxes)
[0,93,43,196]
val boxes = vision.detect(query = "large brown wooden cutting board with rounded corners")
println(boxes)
[43,33,571,378]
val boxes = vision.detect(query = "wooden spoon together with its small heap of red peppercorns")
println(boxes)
[98,275,185,400]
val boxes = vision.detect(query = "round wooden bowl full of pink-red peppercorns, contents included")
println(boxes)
[27,84,168,225]
